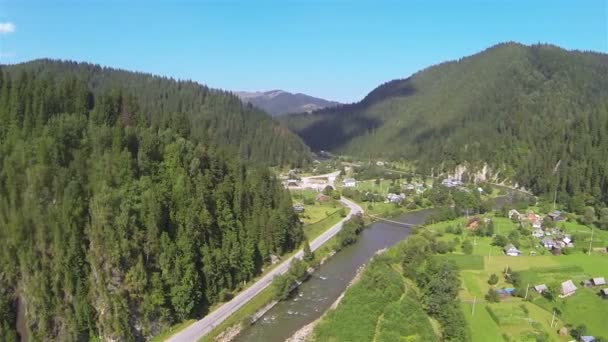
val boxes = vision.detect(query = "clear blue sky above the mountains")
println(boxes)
[0,0,608,102]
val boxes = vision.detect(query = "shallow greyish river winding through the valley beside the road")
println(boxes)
[235,209,433,342]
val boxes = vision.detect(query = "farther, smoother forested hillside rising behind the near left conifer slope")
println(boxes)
[3,59,310,166]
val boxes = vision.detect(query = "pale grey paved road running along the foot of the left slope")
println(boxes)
[168,198,363,342]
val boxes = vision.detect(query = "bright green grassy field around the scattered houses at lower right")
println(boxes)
[428,218,608,341]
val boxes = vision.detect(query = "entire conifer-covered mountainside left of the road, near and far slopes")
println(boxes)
[0,61,307,341]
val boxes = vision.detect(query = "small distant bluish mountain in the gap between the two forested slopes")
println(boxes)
[235,90,339,116]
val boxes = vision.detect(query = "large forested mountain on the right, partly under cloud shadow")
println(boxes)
[284,43,608,211]
